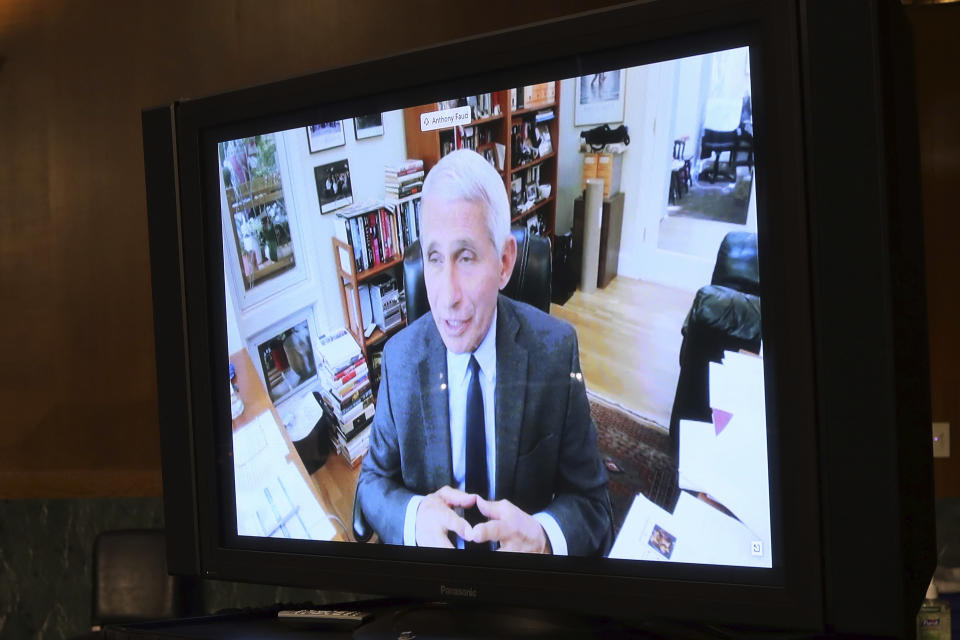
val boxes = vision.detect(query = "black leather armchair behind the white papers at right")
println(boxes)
[670,231,761,456]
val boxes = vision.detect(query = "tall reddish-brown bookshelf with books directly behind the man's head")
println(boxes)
[403,82,560,244]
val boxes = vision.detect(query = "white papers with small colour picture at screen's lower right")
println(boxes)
[610,491,773,567]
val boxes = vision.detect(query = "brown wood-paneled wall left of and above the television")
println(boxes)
[0,0,612,497]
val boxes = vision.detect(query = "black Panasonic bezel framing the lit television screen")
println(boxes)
[165,1,823,628]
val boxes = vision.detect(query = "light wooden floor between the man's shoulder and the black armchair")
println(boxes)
[550,276,694,427]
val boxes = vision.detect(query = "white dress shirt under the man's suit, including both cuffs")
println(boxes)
[403,309,567,555]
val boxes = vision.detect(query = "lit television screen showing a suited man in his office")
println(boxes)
[216,46,776,572]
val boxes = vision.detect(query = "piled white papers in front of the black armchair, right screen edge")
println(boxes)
[679,352,770,550]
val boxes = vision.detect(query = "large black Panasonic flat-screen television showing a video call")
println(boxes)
[143,0,933,636]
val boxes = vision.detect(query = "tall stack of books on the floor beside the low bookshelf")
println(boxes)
[318,328,374,467]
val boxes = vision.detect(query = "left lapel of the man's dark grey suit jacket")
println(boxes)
[414,318,453,491]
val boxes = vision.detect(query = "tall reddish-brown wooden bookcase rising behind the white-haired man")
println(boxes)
[403,82,560,244]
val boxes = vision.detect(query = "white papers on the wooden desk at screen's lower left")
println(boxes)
[233,411,336,540]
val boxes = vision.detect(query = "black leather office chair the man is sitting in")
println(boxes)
[353,227,551,542]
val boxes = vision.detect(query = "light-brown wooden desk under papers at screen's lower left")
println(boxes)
[230,350,359,541]
